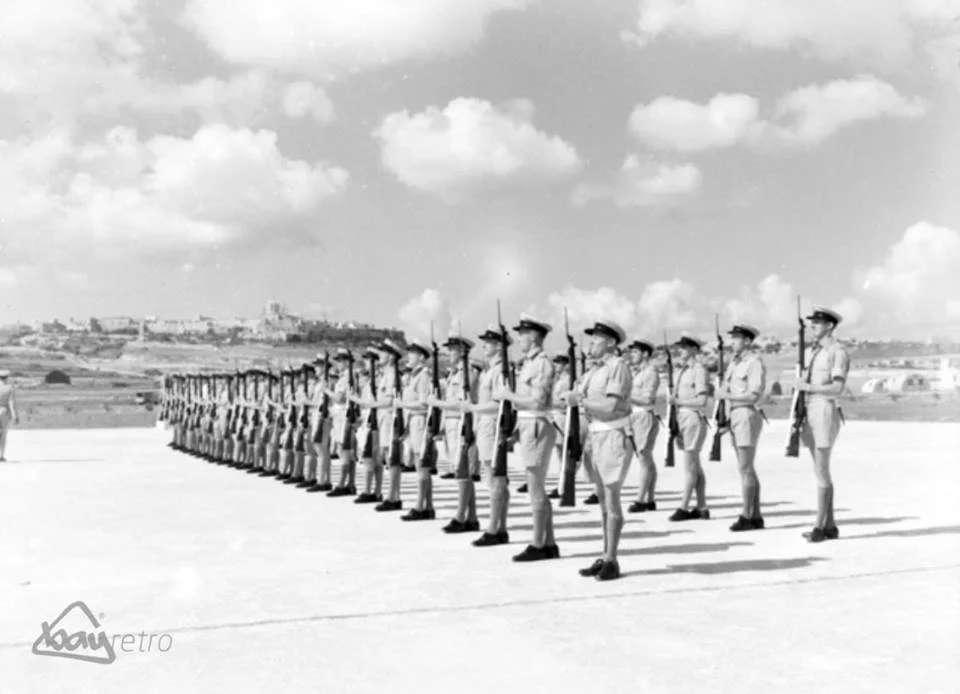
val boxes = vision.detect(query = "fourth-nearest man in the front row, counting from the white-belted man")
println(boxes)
[429,334,480,533]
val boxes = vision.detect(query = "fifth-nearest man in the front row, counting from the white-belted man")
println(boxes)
[399,341,437,521]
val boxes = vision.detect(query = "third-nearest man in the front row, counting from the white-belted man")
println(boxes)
[469,325,512,547]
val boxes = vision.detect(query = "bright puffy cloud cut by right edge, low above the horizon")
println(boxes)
[862,222,960,326]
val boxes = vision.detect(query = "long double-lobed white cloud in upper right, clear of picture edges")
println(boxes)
[629,75,927,153]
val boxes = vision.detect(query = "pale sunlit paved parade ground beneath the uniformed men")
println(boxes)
[0,421,960,694]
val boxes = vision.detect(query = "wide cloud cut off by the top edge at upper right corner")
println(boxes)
[634,0,960,66]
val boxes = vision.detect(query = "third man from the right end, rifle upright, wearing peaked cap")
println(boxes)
[668,335,710,521]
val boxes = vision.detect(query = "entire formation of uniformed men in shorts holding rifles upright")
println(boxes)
[160,308,849,581]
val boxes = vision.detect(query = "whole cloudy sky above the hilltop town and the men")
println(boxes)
[0,0,960,348]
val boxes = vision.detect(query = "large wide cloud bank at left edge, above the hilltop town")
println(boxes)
[0,125,347,260]
